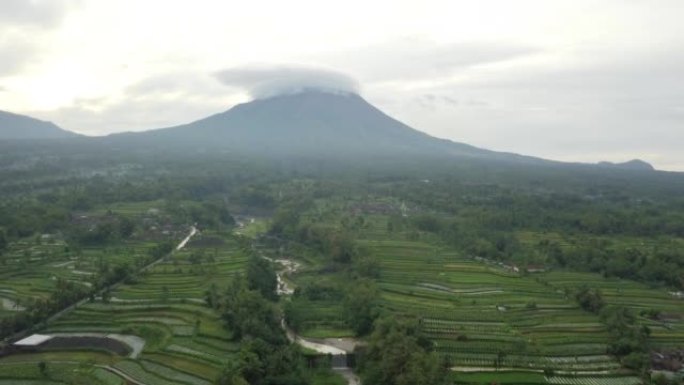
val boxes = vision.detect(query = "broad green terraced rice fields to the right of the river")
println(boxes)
[361,240,684,384]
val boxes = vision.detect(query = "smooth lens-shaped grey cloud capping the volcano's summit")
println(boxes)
[216,66,359,99]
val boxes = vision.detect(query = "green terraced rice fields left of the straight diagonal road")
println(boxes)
[0,201,203,319]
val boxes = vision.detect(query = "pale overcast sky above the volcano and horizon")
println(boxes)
[0,0,684,171]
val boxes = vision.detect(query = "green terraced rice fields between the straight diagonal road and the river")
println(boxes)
[0,230,247,385]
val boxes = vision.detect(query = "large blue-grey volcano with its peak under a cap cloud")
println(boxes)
[113,91,534,159]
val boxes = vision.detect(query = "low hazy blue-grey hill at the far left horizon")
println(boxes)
[0,111,80,140]
